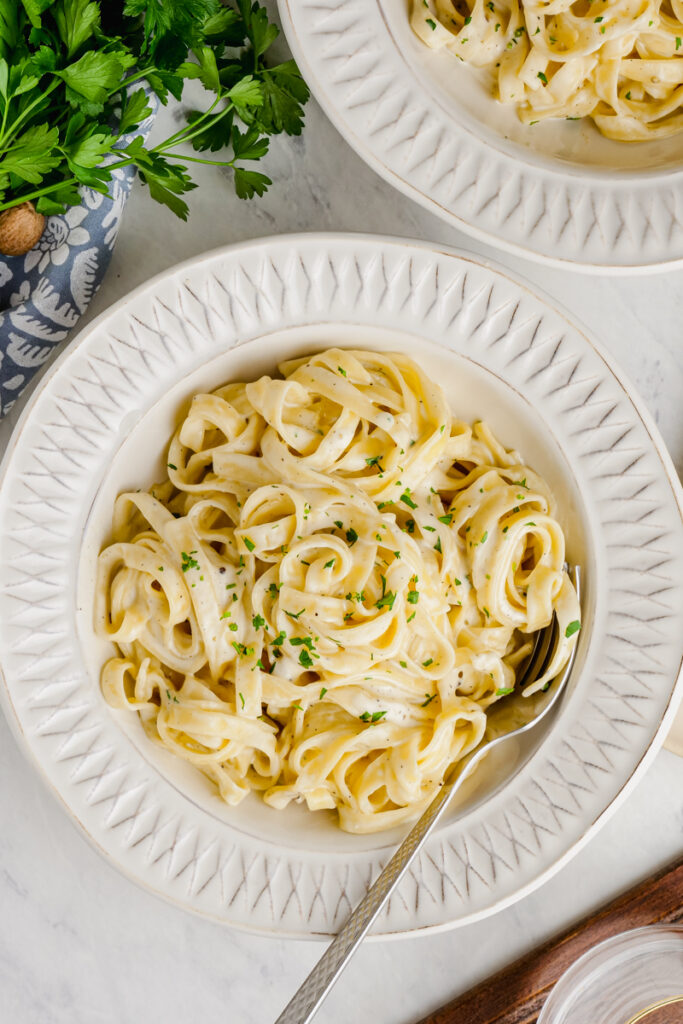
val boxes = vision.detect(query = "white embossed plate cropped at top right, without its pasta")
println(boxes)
[279,0,683,272]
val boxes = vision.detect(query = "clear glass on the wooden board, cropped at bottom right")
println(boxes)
[538,925,683,1024]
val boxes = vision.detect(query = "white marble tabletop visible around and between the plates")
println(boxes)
[0,6,683,1024]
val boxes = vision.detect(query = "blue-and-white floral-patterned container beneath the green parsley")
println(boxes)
[0,107,154,418]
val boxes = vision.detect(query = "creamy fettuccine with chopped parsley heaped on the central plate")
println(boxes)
[94,349,580,833]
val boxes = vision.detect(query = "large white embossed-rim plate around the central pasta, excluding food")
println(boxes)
[0,234,683,936]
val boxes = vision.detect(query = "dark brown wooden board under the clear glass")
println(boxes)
[420,858,683,1024]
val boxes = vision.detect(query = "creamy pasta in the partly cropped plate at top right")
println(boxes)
[411,0,683,142]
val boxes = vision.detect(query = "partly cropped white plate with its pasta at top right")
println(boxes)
[280,0,683,272]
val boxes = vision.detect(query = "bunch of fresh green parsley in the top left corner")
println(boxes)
[0,0,308,220]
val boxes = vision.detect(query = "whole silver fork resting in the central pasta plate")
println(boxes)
[275,566,581,1024]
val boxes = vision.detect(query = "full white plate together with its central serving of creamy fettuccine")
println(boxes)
[0,236,683,935]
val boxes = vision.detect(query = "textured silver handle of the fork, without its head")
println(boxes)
[275,758,472,1024]
